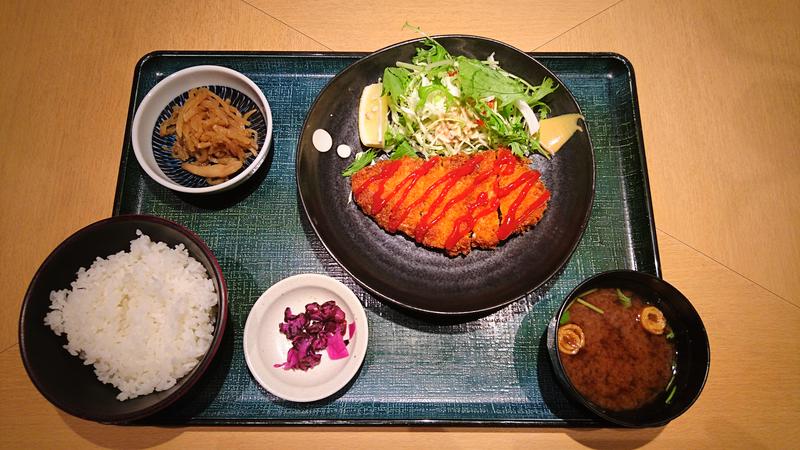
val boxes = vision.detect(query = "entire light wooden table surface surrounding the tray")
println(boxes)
[0,0,800,448]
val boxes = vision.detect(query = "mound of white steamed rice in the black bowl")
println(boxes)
[44,230,217,400]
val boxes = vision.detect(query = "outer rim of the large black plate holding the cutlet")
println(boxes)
[295,33,597,318]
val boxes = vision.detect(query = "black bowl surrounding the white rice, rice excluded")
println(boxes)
[19,216,227,423]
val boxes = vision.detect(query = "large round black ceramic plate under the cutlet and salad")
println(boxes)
[297,36,594,315]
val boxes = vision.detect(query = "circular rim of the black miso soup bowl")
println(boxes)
[547,269,711,428]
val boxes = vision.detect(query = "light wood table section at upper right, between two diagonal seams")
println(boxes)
[538,0,800,305]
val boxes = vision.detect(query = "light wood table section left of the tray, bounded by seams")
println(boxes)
[0,0,324,349]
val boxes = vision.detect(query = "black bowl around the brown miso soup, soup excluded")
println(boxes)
[547,270,710,427]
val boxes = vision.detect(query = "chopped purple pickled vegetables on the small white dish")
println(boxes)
[274,300,355,371]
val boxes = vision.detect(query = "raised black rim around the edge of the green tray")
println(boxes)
[112,50,662,428]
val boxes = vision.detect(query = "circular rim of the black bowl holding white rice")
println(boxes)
[18,214,228,423]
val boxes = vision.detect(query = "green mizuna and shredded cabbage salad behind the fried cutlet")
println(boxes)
[342,33,557,176]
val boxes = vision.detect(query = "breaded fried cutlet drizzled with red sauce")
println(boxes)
[350,149,550,256]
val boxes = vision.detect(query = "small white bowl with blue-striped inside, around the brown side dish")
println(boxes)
[131,66,272,194]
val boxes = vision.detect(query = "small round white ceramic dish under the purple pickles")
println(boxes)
[244,274,369,402]
